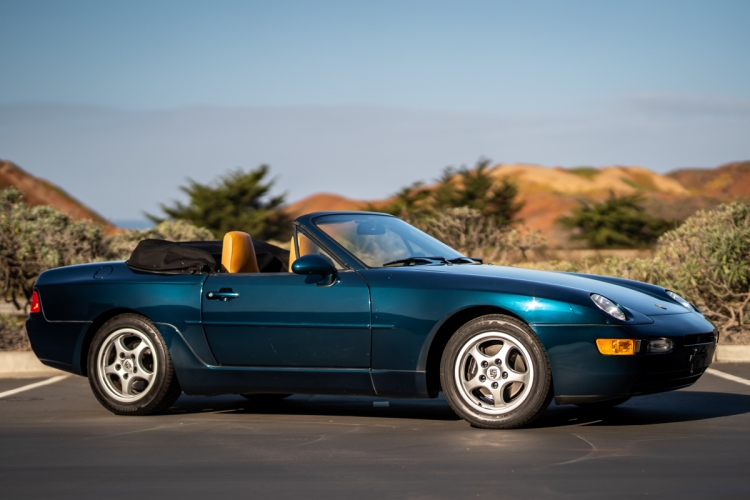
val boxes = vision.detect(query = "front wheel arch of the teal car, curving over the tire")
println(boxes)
[425,305,526,398]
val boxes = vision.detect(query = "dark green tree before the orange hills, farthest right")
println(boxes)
[558,192,675,248]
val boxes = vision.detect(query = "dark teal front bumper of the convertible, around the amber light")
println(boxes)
[534,313,716,404]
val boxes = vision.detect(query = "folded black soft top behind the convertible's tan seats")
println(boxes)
[125,239,289,274]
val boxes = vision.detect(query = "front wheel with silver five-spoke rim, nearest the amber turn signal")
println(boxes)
[440,314,552,429]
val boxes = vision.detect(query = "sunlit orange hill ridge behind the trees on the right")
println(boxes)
[287,161,750,245]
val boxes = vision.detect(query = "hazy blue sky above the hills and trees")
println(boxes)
[0,0,750,219]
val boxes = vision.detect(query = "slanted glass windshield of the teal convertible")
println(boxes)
[315,214,462,267]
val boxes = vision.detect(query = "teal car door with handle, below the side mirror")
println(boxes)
[202,270,370,368]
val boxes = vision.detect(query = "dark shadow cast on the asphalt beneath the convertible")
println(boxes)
[167,391,750,428]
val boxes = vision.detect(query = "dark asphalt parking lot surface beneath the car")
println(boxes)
[0,364,750,500]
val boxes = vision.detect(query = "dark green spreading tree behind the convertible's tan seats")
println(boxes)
[151,165,291,240]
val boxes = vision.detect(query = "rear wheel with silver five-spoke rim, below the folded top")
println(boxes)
[88,314,182,415]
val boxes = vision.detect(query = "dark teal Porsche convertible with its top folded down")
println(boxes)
[27,212,718,428]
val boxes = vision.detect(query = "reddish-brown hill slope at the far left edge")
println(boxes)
[0,160,113,228]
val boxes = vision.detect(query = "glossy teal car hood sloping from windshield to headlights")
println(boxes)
[410,264,690,316]
